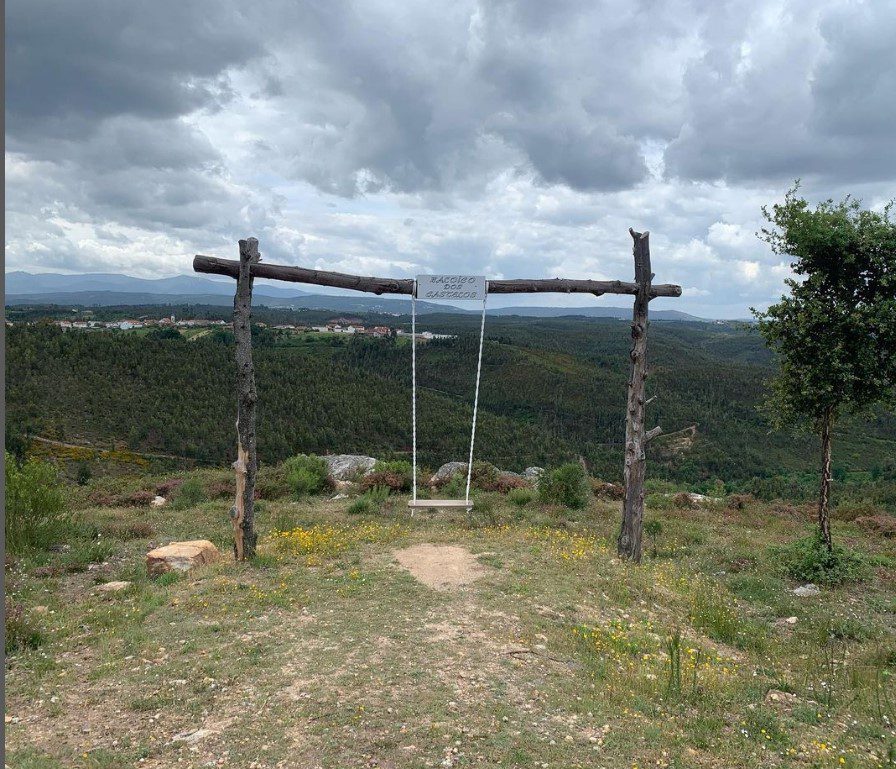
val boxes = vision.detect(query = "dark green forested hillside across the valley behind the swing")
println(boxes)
[7,316,896,493]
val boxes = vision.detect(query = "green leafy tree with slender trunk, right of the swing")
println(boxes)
[753,183,896,551]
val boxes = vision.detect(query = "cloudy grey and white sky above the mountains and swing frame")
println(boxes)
[6,0,896,317]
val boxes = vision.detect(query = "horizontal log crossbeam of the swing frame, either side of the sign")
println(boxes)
[193,255,681,299]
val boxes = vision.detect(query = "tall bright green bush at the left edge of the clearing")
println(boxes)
[4,453,72,553]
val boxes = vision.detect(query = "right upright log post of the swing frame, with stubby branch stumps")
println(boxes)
[617,230,660,563]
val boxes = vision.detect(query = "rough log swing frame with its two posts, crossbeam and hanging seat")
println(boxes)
[193,229,681,562]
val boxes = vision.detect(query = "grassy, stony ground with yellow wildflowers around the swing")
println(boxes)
[6,471,896,768]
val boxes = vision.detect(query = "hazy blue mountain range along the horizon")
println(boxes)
[6,272,701,321]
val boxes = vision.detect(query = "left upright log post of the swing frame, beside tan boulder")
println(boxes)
[230,238,261,561]
